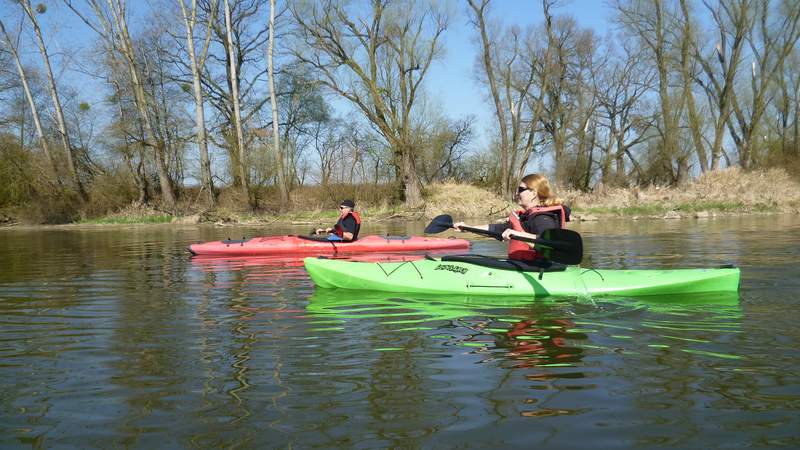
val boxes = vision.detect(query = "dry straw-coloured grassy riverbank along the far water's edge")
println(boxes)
[0,169,800,226]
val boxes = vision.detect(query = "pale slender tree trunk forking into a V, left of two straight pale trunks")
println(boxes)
[178,0,217,205]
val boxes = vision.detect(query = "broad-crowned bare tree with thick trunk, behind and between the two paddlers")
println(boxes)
[291,0,447,205]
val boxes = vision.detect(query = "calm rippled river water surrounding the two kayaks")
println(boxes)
[0,216,800,448]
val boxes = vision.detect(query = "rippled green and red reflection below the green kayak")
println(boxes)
[307,289,741,368]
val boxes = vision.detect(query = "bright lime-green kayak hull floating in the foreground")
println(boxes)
[303,258,739,297]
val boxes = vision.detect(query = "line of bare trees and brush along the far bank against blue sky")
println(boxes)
[0,0,800,221]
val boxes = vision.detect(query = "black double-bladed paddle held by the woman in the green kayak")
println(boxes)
[425,214,583,265]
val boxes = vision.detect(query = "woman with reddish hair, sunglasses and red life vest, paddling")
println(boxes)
[453,173,570,261]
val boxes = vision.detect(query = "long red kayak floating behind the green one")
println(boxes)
[189,235,469,256]
